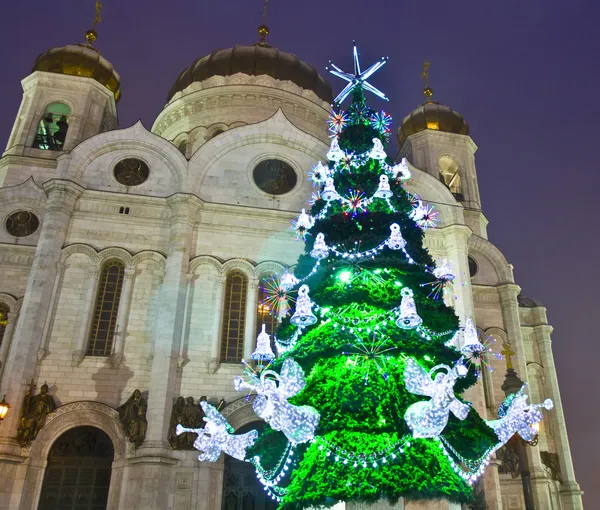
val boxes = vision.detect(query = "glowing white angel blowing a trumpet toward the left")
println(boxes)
[175,401,258,462]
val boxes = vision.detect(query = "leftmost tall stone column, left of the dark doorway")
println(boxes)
[0,179,83,442]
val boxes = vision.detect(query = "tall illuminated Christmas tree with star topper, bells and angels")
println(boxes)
[177,42,551,509]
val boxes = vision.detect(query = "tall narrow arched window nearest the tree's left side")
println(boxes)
[221,269,248,363]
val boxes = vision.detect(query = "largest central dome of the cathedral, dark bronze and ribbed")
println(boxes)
[167,43,333,103]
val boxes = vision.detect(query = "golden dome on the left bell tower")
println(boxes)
[32,43,121,101]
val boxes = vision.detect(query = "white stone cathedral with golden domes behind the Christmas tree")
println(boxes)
[0,21,583,510]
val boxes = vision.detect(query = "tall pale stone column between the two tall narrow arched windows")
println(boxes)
[130,194,201,510]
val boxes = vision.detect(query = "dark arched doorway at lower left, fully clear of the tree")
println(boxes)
[38,427,115,510]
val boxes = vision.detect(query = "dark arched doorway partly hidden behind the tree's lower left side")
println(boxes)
[221,422,277,510]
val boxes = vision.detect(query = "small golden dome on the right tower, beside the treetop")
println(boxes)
[398,100,469,147]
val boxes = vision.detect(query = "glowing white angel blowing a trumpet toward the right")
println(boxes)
[486,384,554,444]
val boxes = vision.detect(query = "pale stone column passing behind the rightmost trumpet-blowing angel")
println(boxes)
[497,283,552,510]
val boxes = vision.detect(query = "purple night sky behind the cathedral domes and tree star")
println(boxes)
[0,0,600,510]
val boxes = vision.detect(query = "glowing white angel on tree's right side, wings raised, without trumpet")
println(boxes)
[404,358,471,438]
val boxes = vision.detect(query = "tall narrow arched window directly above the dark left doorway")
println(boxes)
[87,260,125,356]
